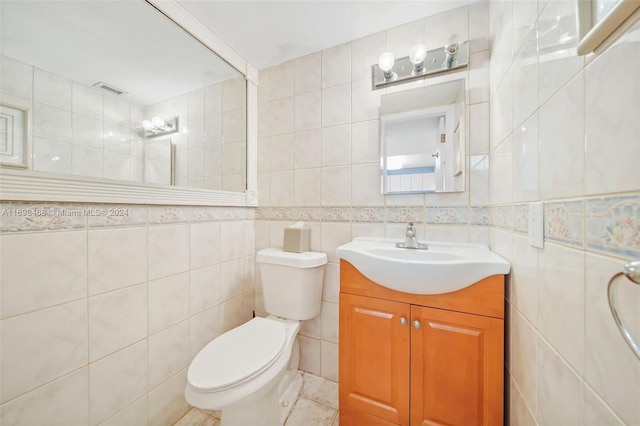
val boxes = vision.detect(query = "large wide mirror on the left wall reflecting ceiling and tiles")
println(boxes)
[0,0,257,205]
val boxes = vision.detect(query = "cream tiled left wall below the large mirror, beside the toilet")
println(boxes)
[0,202,255,426]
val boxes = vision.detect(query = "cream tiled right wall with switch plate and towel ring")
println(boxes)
[489,0,640,425]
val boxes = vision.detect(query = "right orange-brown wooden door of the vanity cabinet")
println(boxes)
[411,306,504,426]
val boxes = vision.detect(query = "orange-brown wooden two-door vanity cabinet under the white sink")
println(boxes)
[339,260,504,426]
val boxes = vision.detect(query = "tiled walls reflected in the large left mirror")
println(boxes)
[0,55,246,192]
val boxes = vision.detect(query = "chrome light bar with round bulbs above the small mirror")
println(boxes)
[371,41,469,90]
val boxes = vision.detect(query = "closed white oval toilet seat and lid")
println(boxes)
[187,317,287,392]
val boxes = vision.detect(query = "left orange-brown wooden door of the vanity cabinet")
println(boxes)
[339,293,410,426]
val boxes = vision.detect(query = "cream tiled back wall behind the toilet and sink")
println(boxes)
[256,2,489,380]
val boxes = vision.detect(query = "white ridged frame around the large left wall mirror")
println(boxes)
[0,0,258,207]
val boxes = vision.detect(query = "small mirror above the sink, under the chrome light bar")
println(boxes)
[380,79,466,194]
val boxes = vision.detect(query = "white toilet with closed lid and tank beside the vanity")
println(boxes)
[185,248,327,426]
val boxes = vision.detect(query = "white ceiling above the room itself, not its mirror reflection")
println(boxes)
[177,0,476,69]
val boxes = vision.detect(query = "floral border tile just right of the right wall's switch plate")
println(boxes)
[544,200,584,248]
